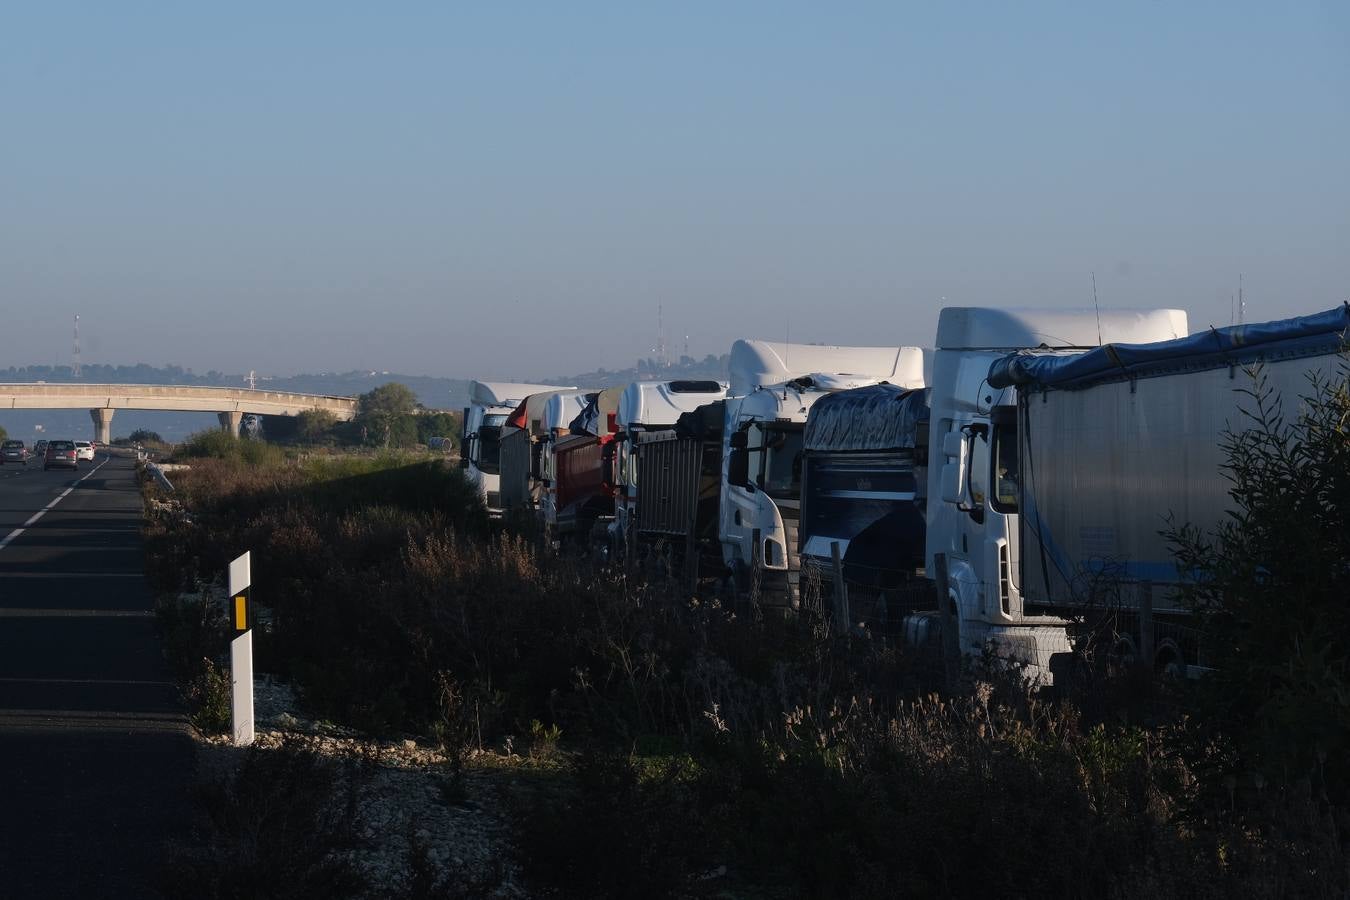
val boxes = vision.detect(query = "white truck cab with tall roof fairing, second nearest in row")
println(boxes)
[718,340,923,607]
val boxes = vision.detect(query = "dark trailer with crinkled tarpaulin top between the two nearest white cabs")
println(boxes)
[798,385,933,637]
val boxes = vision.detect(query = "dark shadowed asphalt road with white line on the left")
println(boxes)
[0,456,193,899]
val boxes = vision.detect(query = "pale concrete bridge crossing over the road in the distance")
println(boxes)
[0,383,356,444]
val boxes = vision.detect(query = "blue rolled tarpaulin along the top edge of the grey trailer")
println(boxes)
[993,304,1350,391]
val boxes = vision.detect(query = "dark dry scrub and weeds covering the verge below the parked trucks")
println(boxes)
[147,372,1350,897]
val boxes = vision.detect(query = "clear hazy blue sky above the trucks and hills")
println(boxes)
[0,0,1350,379]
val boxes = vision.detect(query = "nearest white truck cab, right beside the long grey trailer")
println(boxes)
[923,306,1187,681]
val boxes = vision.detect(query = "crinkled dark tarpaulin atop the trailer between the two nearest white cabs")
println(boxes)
[805,385,929,451]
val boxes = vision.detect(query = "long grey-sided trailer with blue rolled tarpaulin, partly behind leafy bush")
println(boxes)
[982,305,1350,676]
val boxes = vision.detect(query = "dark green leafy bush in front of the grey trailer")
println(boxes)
[1166,364,1350,804]
